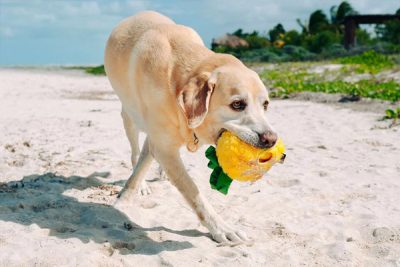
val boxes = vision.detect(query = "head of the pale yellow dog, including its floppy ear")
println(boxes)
[178,57,277,148]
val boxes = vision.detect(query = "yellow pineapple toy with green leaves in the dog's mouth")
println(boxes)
[206,131,286,194]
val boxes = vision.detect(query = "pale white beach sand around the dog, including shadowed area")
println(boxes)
[0,69,400,266]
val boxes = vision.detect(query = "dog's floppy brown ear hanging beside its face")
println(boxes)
[178,72,216,129]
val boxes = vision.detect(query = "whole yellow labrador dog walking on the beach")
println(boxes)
[105,11,277,243]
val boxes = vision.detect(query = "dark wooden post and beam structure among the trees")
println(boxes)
[344,15,400,49]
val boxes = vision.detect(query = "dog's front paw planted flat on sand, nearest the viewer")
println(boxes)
[210,223,253,246]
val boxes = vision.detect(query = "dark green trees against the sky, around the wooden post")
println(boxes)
[213,1,400,61]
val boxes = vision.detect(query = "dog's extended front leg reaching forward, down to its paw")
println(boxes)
[153,146,249,244]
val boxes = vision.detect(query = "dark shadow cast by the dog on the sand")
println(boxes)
[0,173,206,255]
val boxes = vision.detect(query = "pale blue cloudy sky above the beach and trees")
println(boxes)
[0,0,400,66]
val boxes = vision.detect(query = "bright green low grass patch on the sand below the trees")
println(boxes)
[260,51,400,102]
